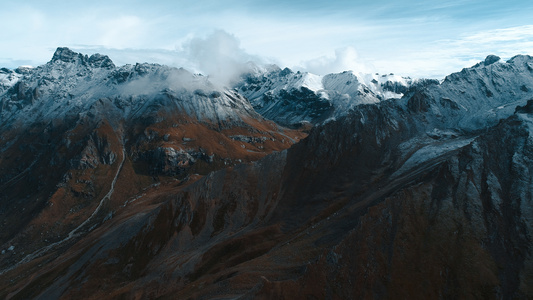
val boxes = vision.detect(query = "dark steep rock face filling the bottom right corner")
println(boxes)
[258,115,533,299]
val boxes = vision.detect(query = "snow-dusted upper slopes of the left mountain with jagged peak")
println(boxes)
[0,48,259,129]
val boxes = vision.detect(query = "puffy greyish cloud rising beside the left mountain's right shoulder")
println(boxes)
[179,30,261,85]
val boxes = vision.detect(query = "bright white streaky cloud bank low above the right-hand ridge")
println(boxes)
[340,25,533,79]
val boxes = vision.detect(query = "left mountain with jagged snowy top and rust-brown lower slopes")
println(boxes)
[0,48,304,276]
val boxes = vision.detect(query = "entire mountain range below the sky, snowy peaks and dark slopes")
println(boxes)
[0,48,533,299]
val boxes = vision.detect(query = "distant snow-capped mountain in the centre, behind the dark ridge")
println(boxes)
[235,65,419,127]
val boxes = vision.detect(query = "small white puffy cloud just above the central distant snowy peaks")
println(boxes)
[301,47,372,75]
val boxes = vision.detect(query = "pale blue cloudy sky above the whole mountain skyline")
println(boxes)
[0,0,533,78]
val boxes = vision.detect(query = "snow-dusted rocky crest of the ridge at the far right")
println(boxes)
[403,55,533,130]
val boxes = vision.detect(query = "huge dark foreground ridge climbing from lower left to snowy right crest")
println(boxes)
[0,51,533,299]
